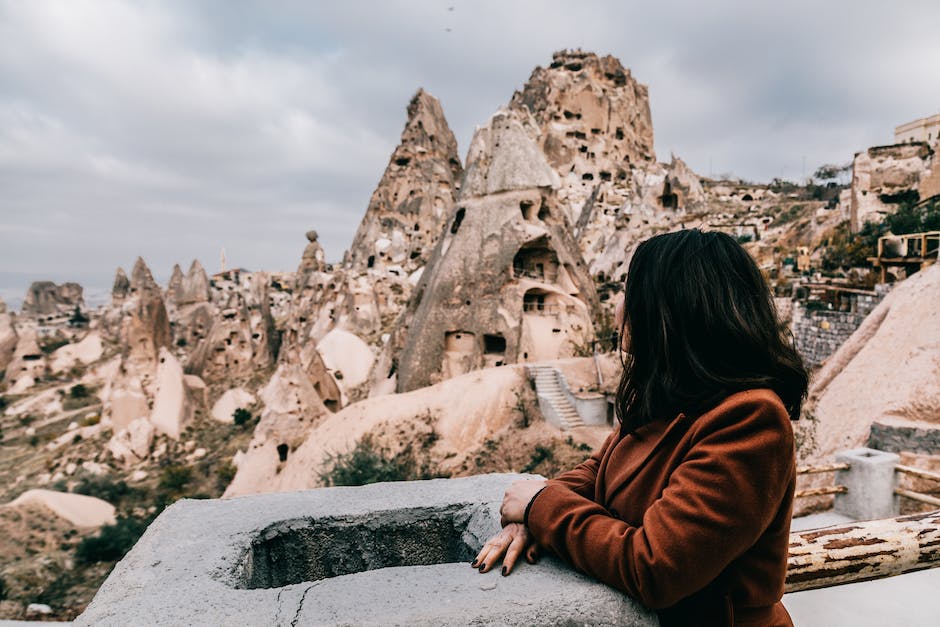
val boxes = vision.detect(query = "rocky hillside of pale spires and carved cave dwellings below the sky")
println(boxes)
[0,51,936,618]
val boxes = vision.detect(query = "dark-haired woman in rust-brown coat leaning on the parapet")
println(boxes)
[473,230,807,627]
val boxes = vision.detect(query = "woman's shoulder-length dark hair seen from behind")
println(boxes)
[617,229,807,434]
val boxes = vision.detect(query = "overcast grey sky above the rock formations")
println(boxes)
[0,0,940,310]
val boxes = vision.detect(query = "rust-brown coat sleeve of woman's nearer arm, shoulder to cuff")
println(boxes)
[528,397,795,609]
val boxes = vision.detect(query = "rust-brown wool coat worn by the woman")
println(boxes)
[526,389,796,627]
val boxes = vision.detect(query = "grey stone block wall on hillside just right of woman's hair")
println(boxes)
[790,286,886,366]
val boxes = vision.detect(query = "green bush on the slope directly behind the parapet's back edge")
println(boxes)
[320,435,441,486]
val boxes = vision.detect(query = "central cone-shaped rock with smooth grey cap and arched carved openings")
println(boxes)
[392,109,597,392]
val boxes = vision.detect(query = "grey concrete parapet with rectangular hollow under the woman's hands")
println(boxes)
[75,474,658,627]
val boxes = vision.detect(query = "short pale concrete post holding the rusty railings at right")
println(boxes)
[833,448,901,520]
